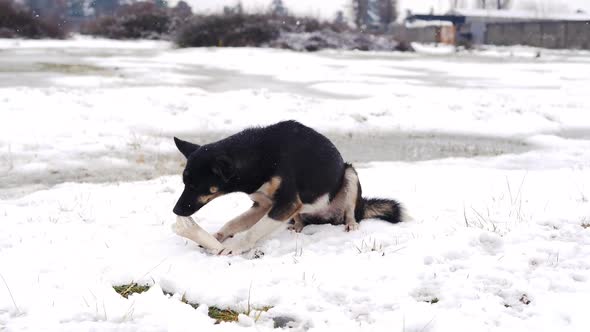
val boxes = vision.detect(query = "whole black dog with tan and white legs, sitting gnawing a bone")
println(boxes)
[174,121,401,254]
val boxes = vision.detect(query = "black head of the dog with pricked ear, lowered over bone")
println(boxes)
[173,137,235,217]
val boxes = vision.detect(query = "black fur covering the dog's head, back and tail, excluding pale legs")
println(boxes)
[174,121,400,227]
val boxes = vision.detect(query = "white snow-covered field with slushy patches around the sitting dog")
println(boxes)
[0,39,590,332]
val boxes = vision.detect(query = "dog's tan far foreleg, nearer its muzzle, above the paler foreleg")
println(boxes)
[214,192,272,242]
